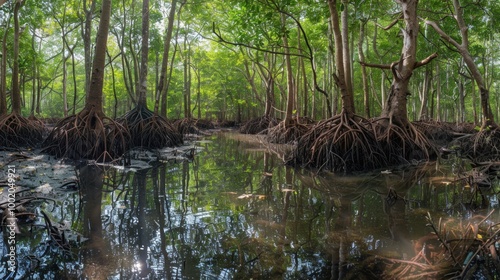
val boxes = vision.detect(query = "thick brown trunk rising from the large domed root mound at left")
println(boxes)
[85,0,111,114]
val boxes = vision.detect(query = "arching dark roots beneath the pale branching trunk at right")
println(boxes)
[378,123,436,164]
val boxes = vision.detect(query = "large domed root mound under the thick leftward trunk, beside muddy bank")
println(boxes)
[42,109,130,162]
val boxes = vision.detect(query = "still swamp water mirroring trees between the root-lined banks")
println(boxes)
[0,132,498,279]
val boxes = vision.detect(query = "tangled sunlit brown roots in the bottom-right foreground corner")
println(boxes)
[383,211,500,279]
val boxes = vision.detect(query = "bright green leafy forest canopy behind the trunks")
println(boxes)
[0,0,500,123]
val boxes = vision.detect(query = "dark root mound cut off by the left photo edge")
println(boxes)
[0,113,45,148]
